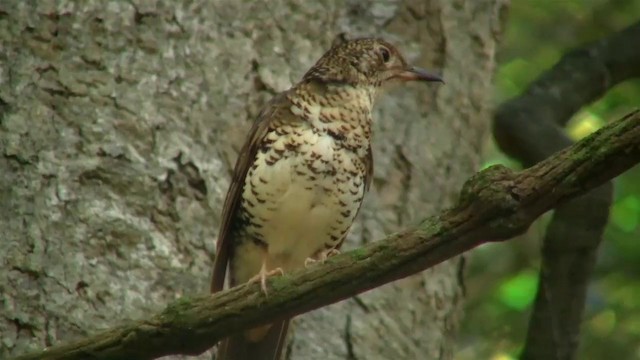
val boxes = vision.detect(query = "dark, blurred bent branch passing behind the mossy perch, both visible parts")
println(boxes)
[493,22,640,359]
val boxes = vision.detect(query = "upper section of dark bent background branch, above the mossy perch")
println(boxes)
[493,21,640,164]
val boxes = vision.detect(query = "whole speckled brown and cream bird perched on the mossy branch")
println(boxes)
[211,35,442,360]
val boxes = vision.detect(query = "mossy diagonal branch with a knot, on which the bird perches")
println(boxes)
[17,111,640,360]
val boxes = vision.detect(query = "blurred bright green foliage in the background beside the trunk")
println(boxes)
[457,0,640,360]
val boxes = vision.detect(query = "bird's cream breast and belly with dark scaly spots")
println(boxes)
[231,82,372,283]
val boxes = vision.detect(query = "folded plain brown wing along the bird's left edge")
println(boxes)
[211,92,294,293]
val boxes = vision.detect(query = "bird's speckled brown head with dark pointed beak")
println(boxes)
[304,34,443,87]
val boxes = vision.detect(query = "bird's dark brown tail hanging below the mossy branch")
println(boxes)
[214,319,289,360]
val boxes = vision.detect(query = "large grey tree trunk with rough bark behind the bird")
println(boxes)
[0,0,507,359]
